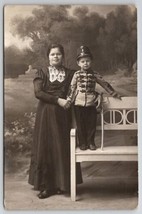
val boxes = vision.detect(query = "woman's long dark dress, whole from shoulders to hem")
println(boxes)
[29,67,82,191]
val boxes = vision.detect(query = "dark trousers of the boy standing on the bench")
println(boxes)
[74,106,97,146]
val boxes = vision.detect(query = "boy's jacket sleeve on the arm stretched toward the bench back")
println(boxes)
[95,73,116,96]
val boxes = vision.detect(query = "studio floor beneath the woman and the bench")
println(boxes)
[4,175,138,210]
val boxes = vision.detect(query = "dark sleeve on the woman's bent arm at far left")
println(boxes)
[33,70,59,104]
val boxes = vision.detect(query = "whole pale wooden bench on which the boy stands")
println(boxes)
[70,97,138,201]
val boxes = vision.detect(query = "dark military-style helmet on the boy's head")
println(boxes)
[77,46,93,61]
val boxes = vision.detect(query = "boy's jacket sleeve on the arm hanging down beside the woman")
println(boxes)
[67,73,77,102]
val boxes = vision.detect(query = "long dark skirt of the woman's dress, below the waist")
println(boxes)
[29,101,82,191]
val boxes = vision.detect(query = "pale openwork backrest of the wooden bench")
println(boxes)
[101,97,137,130]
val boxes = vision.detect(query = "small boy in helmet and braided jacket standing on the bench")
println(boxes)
[66,46,121,150]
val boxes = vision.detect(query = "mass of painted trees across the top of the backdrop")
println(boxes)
[8,5,137,72]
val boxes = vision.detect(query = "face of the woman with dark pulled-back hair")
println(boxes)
[49,48,63,66]
